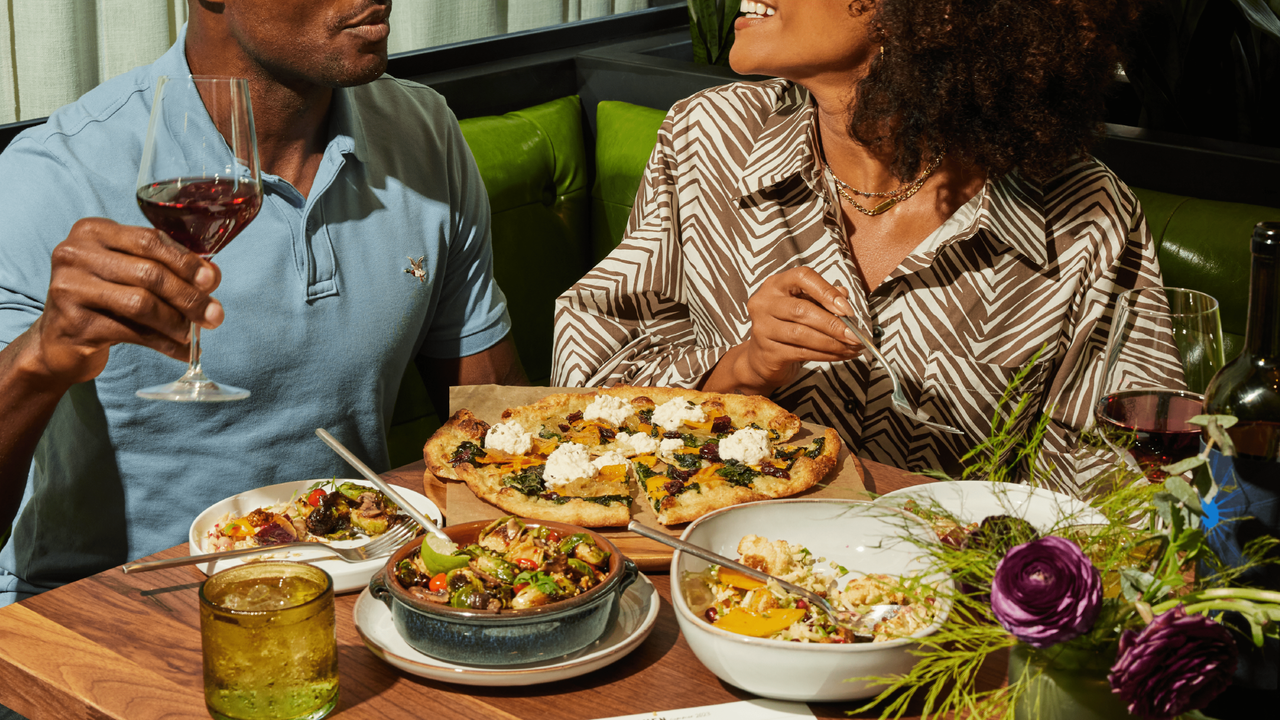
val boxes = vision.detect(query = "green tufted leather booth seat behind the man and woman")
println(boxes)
[389,97,1280,465]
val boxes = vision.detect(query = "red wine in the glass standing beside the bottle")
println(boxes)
[1096,389,1202,480]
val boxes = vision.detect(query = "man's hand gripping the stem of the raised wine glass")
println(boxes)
[28,218,223,387]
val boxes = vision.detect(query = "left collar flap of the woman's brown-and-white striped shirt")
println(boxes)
[737,83,819,199]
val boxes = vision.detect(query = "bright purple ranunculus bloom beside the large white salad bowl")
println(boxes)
[991,537,1102,647]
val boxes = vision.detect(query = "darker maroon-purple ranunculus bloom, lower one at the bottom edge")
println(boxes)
[1107,605,1235,720]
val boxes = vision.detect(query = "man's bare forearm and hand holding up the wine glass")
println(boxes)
[0,218,223,528]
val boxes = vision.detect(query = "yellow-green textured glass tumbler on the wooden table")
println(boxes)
[200,562,338,720]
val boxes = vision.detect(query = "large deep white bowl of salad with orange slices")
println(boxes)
[671,500,950,702]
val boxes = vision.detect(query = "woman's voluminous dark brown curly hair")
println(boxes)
[849,0,1143,179]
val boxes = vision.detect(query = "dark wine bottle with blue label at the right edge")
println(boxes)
[1204,223,1280,717]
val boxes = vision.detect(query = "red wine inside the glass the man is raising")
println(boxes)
[138,179,262,259]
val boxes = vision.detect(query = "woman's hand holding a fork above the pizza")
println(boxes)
[703,268,861,395]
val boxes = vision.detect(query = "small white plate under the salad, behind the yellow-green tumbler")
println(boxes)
[187,479,442,592]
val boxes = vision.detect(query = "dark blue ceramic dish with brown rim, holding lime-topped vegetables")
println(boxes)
[369,520,639,665]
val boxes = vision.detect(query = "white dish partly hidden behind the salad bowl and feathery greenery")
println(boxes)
[876,480,1107,533]
